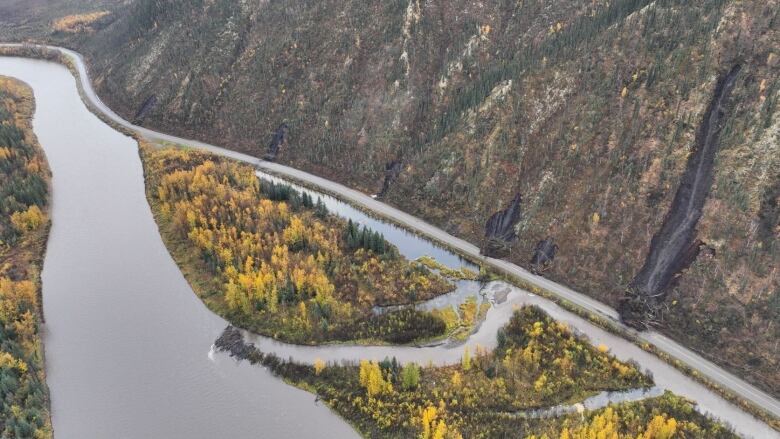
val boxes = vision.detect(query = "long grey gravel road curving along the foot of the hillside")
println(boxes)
[6,44,780,418]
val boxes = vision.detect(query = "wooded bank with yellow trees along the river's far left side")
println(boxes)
[0,76,52,439]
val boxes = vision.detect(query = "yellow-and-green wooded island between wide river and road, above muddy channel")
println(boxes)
[142,146,454,343]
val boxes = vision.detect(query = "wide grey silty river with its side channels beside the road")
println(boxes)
[0,57,780,439]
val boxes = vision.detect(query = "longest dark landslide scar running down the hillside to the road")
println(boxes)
[619,65,740,329]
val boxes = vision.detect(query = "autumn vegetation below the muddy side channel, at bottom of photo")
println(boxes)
[217,307,734,439]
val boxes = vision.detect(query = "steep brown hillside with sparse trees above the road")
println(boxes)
[0,0,780,395]
